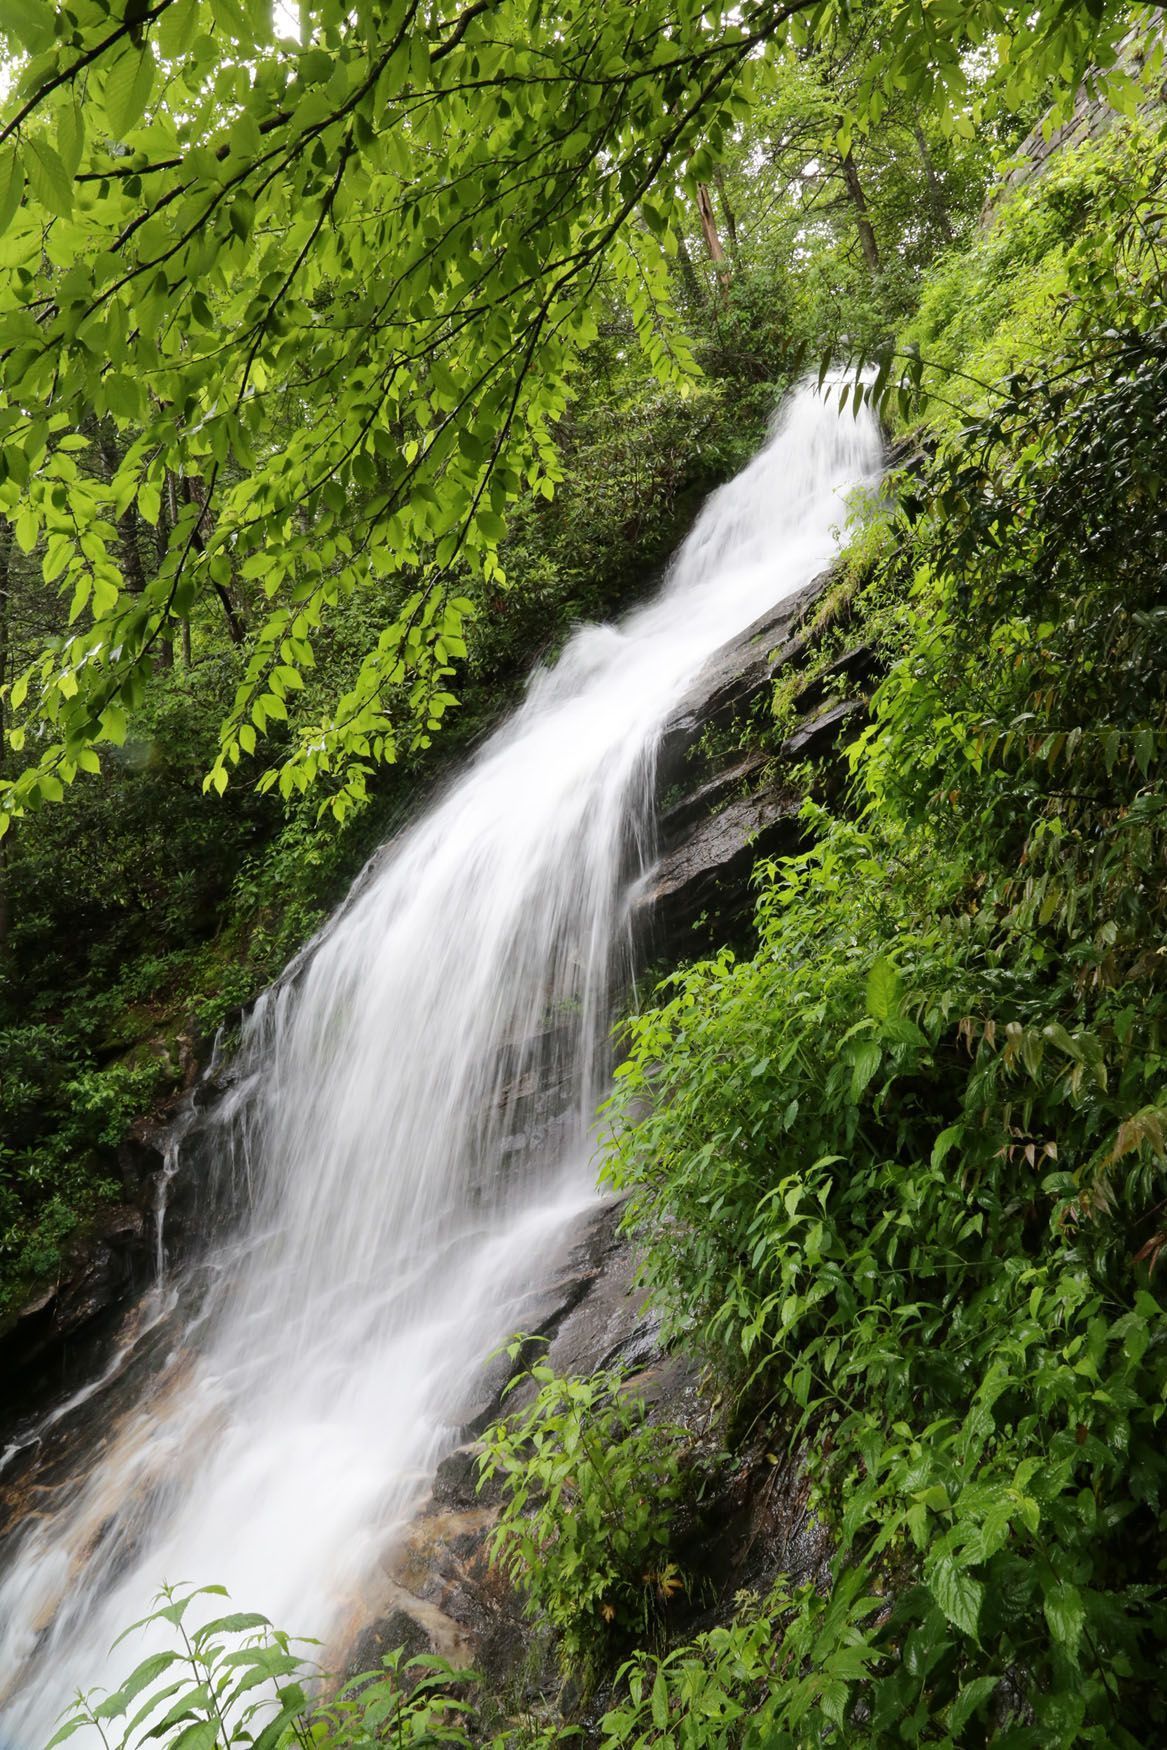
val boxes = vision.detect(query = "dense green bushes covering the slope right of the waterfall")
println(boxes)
[611,301,1167,1747]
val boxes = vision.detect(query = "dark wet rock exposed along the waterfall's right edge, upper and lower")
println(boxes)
[365,576,878,1706]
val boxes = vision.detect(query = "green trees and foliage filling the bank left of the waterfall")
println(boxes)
[0,0,1028,1318]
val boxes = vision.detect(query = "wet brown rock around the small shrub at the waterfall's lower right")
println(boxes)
[360,1204,831,1706]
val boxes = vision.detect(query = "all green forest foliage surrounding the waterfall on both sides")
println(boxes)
[0,0,1167,1750]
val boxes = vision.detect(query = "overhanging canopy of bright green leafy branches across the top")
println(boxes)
[0,0,1147,826]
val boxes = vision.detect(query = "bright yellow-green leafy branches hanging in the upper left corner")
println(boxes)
[0,0,776,819]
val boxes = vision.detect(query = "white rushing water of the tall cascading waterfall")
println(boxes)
[0,389,878,1750]
